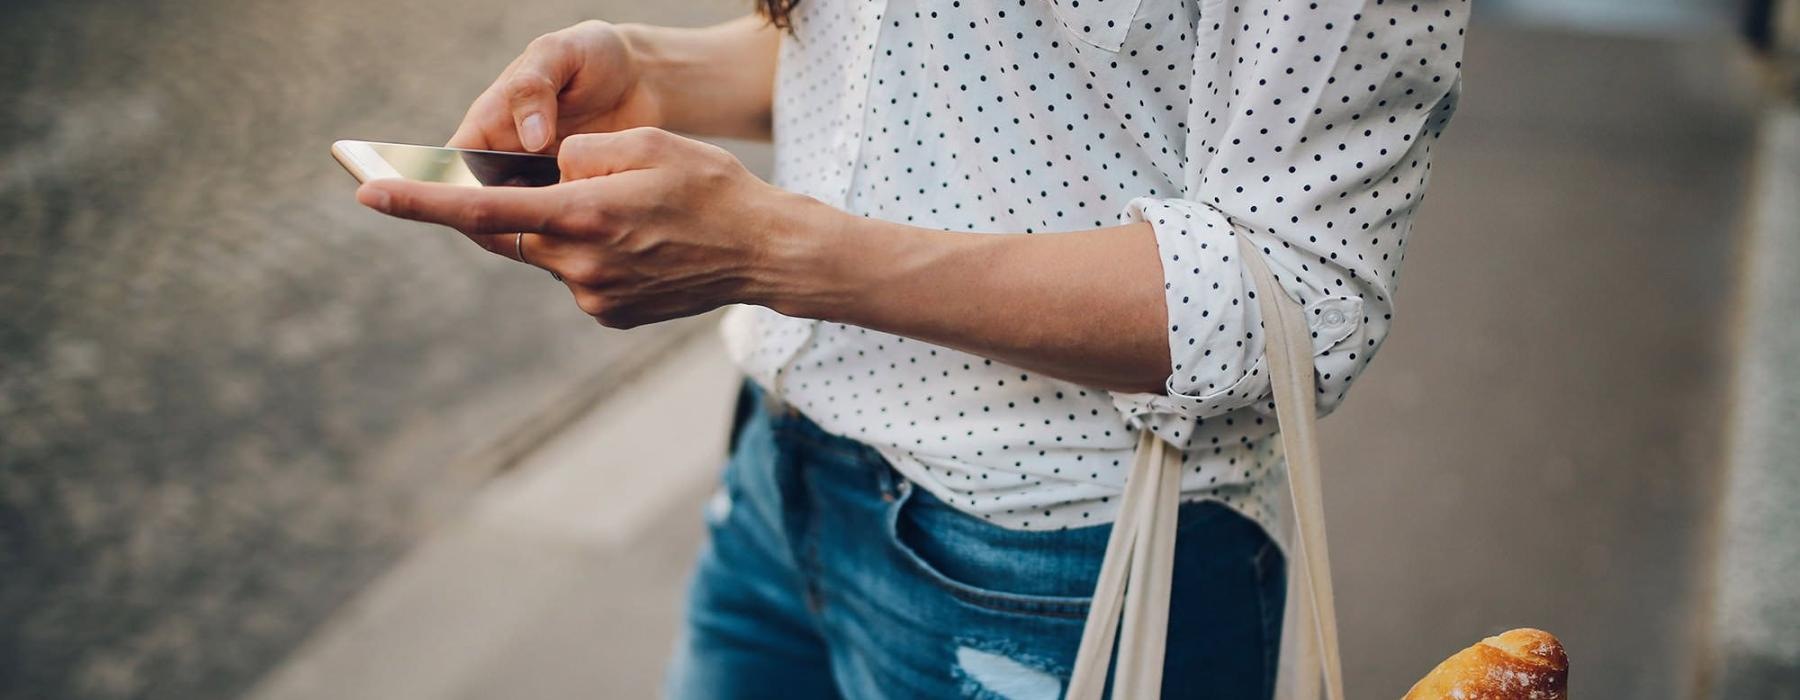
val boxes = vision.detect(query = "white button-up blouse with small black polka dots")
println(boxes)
[724,0,1469,538]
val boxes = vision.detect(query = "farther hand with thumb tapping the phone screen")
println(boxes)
[450,20,662,153]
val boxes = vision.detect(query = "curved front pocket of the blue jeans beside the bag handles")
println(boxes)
[886,482,1105,619]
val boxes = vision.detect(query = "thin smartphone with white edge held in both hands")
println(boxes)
[331,140,562,187]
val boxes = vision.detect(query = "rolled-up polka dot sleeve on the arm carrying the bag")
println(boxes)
[1114,0,1469,444]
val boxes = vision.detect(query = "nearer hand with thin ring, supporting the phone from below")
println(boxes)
[367,128,848,328]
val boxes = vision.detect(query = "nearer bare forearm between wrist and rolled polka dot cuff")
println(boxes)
[767,206,1170,392]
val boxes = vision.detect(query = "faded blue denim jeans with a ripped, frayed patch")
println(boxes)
[668,383,1285,700]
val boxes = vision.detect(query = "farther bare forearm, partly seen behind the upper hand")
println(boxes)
[619,16,781,140]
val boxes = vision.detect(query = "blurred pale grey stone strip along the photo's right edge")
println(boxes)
[1710,104,1800,700]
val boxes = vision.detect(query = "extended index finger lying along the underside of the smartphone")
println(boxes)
[356,180,565,234]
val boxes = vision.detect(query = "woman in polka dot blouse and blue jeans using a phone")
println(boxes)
[358,0,1469,698]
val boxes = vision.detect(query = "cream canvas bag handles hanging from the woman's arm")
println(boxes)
[1066,232,1345,700]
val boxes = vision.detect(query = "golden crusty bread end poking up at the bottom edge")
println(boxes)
[1404,628,1570,700]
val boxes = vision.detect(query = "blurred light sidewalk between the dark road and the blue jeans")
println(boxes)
[248,333,736,700]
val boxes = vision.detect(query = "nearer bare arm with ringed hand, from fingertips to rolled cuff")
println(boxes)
[356,128,1170,386]
